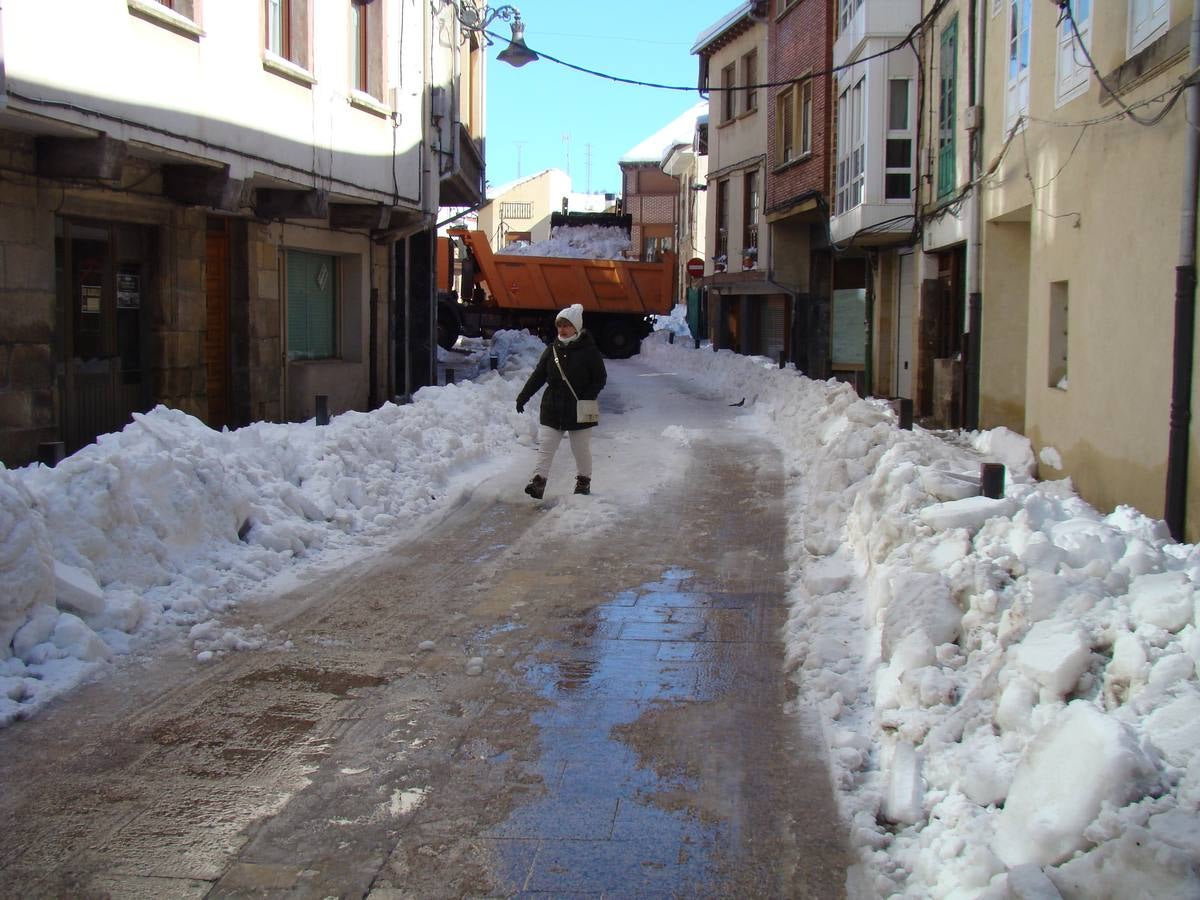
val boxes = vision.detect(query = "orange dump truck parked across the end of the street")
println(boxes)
[438,228,676,359]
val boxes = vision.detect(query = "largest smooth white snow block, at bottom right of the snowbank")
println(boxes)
[991,701,1154,866]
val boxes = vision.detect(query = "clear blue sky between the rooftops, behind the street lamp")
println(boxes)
[486,0,739,193]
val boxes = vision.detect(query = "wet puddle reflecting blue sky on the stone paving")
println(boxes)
[491,569,733,896]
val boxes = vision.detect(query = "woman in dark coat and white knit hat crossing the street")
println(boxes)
[517,304,608,500]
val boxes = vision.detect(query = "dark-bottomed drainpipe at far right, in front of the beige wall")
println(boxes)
[1165,0,1200,541]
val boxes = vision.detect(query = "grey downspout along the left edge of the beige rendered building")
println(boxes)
[962,0,988,431]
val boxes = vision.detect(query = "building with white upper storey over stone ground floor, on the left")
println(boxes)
[0,0,482,466]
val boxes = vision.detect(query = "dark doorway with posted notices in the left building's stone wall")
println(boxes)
[54,217,156,452]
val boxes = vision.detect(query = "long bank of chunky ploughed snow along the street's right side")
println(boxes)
[643,338,1200,900]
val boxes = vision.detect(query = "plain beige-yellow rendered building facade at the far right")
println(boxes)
[974,0,1200,540]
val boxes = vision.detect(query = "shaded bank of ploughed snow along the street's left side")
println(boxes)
[0,332,544,725]
